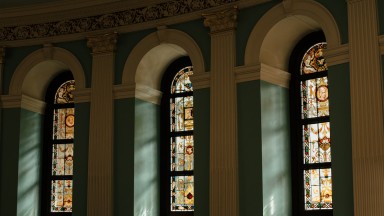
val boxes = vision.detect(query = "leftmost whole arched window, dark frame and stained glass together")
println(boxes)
[42,72,75,215]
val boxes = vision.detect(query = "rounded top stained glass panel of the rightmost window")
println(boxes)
[300,43,328,74]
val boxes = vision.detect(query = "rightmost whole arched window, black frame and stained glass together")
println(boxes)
[290,32,333,215]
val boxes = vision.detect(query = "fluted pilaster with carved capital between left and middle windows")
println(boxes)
[87,34,117,216]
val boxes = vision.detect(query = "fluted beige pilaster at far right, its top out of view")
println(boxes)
[346,0,384,216]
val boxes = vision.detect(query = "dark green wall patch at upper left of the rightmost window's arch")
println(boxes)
[236,0,281,66]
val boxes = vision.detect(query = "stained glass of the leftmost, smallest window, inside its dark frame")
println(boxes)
[46,78,75,215]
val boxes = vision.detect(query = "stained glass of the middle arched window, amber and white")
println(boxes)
[168,67,194,212]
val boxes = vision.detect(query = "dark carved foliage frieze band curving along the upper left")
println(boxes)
[0,0,238,41]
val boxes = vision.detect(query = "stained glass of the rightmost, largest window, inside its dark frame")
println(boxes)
[297,42,333,212]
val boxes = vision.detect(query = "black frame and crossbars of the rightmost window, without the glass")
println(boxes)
[289,31,334,216]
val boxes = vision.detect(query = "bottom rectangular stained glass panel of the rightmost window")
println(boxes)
[304,169,333,210]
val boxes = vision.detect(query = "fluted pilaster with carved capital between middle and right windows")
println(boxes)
[204,8,239,216]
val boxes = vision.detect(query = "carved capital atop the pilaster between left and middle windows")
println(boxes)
[87,33,117,54]
